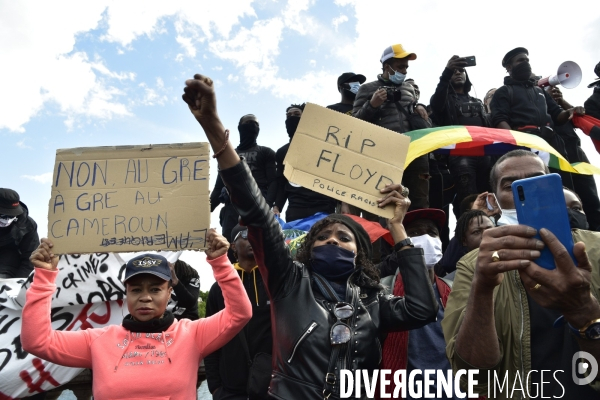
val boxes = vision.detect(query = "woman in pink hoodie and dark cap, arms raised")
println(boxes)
[21,230,252,400]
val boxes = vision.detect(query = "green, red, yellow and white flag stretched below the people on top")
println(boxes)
[405,126,600,175]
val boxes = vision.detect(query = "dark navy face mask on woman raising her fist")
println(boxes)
[310,244,355,281]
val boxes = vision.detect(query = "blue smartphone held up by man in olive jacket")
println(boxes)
[512,174,577,269]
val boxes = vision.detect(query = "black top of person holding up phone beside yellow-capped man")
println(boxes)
[430,68,490,126]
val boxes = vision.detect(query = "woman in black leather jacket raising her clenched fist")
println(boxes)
[183,75,438,399]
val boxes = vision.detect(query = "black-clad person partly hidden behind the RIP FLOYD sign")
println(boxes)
[267,103,337,222]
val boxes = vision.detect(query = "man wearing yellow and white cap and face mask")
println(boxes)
[352,44,431,210]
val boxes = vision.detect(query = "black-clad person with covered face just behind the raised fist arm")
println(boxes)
[210,114,275,244]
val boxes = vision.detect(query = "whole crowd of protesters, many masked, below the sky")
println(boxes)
[12,44,600,400]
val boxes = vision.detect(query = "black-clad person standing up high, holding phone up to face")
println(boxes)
[430,56,492,218]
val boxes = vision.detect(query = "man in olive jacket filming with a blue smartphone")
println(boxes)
[442,150,600,399]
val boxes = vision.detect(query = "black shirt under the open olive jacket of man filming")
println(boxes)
[523,295,600,400]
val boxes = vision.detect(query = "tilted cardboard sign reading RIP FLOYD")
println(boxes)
[284,103,410,218]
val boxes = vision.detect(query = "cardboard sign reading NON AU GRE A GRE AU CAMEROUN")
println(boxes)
[48,143,210,254]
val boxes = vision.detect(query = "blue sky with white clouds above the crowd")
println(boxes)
[0,0,600,290]
